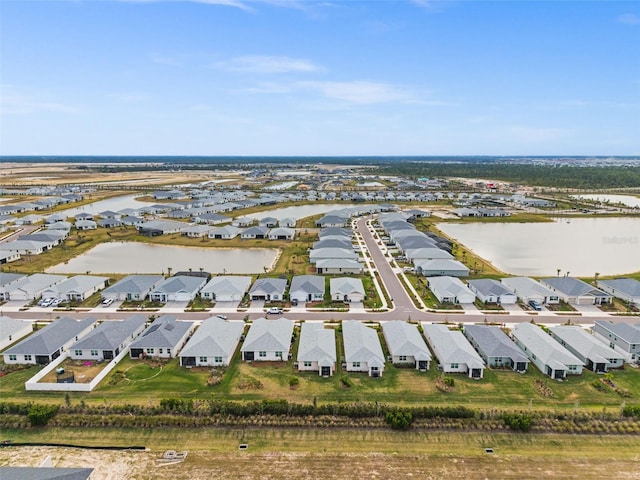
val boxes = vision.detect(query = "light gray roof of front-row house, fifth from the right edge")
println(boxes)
[422,322,484,368]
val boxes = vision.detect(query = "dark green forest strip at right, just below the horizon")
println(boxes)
[377,162,640,189]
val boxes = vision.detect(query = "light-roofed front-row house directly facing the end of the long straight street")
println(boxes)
[382,320,431,372]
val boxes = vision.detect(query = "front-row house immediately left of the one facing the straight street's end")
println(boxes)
[342,320,384,377]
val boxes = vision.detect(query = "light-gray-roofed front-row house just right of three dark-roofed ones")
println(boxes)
[180,317,244,367]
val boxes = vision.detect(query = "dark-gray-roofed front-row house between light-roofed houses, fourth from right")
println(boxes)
[464,325,529,372]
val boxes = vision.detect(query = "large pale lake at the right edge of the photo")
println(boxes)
[438,217,640,277]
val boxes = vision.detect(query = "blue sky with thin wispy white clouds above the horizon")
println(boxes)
[0,0,640,155]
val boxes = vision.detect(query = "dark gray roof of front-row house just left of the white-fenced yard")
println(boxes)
[4,317,96,355]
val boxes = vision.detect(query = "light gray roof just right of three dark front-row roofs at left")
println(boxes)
[180,317,244,359]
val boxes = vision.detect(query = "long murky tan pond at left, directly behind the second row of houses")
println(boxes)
[46,242,279,274]
